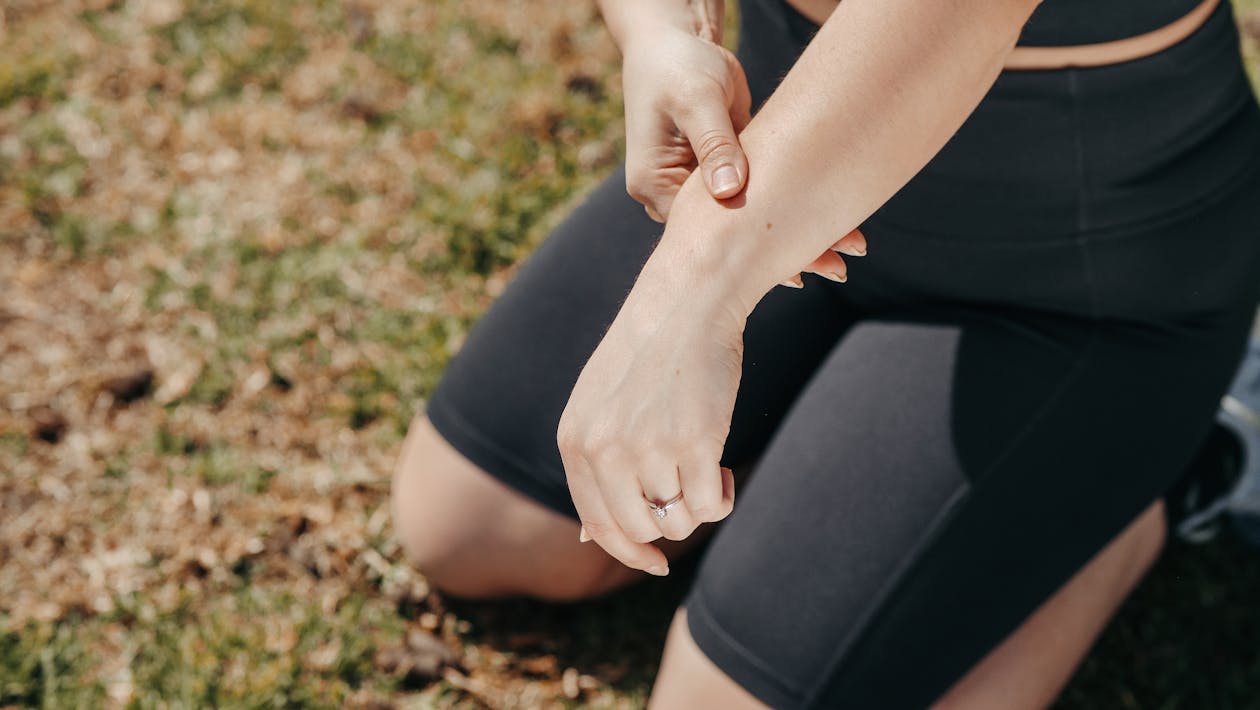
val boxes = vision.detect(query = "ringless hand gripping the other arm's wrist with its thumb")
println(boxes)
[621,18,752,222]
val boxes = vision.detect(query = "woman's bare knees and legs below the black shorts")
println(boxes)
[393,417,1166,710]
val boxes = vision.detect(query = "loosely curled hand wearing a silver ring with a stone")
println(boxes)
[557,274,747,575]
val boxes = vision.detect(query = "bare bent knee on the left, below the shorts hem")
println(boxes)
[392,416,713,600]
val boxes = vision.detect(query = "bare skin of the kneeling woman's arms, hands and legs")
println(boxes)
[394,0,1189,709]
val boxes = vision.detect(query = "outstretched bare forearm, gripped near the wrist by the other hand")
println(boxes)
[640,0,1037,319]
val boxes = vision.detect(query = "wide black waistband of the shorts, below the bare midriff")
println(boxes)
[877,1,1260,240]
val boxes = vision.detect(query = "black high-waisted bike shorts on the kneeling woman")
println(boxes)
[427,0,1260,709]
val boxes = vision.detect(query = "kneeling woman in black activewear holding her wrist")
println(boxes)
[394,0,1260,709]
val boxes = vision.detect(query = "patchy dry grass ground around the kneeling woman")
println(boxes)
[0,0,1260,709]
